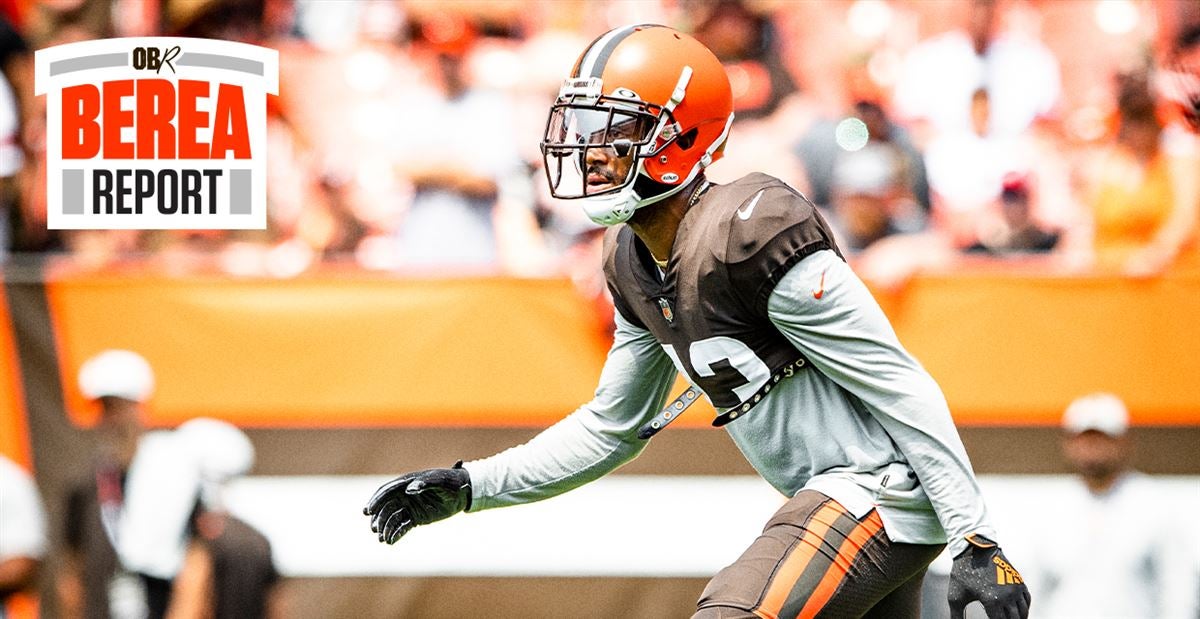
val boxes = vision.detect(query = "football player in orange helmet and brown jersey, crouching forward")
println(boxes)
[364,25,1030,619]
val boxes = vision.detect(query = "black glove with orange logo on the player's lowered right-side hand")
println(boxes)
[948,535,1030,619]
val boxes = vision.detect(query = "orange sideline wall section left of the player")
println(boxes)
[47,275,606,426]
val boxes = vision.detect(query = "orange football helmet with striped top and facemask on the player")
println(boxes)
[541,24,733,226]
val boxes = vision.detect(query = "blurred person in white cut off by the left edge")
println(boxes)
[0,456,46,618]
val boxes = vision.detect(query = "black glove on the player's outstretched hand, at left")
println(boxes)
[362,461,470,543]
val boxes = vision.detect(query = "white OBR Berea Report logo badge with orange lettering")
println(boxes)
[35,37,280,229]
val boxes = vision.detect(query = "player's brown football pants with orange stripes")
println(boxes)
[692,491,943,619]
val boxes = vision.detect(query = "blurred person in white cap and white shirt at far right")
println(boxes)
[1022,393,1196,619]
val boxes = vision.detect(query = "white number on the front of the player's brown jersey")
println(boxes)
[662,336,770,408]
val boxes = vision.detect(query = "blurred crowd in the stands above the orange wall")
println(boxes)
[0,0,1200,287]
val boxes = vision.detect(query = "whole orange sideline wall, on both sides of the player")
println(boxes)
[37,270,1200,427]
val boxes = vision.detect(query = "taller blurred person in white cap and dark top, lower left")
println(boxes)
[58,350,156,619]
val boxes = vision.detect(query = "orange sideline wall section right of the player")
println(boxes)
[877,270,1200,425]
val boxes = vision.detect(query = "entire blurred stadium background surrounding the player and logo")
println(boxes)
[0,0,1200,619]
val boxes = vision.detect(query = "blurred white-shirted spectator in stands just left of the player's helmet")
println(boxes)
[392,16,533,269]
